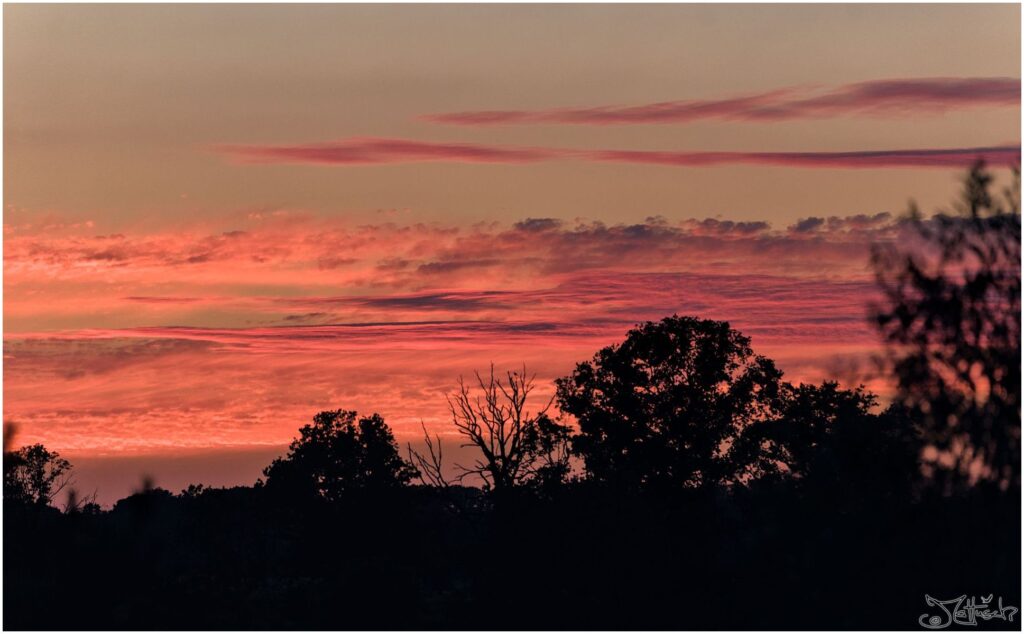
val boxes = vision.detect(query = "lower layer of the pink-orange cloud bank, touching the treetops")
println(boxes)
[4,271,874,454]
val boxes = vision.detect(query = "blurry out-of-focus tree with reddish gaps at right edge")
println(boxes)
[872,163,1021,491]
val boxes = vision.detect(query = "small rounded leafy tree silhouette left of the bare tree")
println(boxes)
[263,410,417,501]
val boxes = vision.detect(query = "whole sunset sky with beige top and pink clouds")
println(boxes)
[3,4,1021,504]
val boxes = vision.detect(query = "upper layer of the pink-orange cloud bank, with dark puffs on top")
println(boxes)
[4,214,898,332]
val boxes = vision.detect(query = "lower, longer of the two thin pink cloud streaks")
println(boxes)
[214,138,1020,170]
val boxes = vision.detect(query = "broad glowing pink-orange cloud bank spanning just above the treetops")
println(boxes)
[4,213,921,467]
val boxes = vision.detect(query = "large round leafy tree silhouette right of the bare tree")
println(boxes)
[557,315,781,488]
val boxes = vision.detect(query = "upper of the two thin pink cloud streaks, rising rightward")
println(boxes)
[422,77,1021,126]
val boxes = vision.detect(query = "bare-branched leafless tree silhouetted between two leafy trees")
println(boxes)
[446,365,569,493]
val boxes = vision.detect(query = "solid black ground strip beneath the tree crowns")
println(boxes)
[3,485,1021,630]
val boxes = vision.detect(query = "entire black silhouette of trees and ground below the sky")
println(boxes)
[3,166,1021,629]
